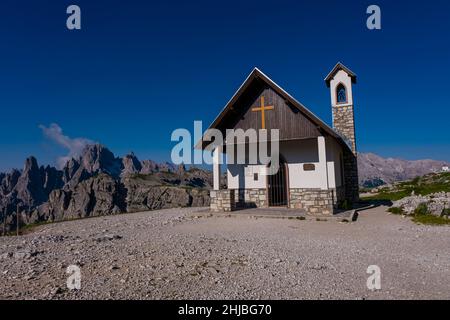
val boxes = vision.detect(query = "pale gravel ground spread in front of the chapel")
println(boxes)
[0,207,450,299]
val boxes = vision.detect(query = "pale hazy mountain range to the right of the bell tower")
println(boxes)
[358,153,450,187]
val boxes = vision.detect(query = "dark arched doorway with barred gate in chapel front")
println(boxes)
[267,155,288,207]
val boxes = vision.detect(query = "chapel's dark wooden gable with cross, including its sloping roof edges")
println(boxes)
[202,68,348,152]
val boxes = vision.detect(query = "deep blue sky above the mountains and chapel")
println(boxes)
[0,0,450,171]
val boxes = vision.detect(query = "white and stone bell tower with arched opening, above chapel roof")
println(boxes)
[325,62,356,155]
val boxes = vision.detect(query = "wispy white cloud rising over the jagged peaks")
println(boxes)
[39,123,94,168]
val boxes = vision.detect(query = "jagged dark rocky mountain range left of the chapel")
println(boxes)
[0,144,212,230]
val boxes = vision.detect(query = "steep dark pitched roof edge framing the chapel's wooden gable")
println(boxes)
[195,67,350,149]
